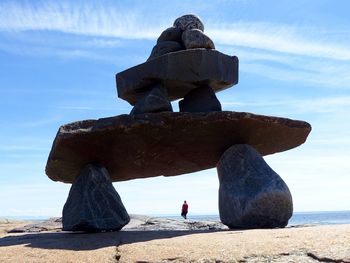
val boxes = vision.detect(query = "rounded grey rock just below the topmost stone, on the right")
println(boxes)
[182,29,215,49]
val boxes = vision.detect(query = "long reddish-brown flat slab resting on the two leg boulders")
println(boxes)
[46,112,311,183]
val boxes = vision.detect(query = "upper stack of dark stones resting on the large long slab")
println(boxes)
[117,15,234,115]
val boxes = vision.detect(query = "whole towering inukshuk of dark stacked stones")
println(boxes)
[46,15,311,231]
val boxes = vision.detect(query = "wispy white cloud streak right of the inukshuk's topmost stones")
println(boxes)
[207,23,350,60]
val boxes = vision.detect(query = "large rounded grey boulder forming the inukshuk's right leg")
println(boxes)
[217,144,293,228]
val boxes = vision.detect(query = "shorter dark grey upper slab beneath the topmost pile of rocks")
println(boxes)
[116,48,238,105]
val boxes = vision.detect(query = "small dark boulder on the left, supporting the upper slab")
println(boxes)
[130,84,173,115]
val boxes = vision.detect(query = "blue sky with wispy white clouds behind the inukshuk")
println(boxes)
[0,0,350,219]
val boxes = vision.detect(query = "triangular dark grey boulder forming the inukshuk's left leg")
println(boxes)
[62,164,130,232]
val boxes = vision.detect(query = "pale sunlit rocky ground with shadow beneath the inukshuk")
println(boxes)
[0,215,350,263]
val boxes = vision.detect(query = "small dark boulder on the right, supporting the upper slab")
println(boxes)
[179,86,221,112]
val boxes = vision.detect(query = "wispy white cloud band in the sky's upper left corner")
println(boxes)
[0,1,160,39]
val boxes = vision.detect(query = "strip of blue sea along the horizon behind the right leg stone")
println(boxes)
[162,211,350,226]
